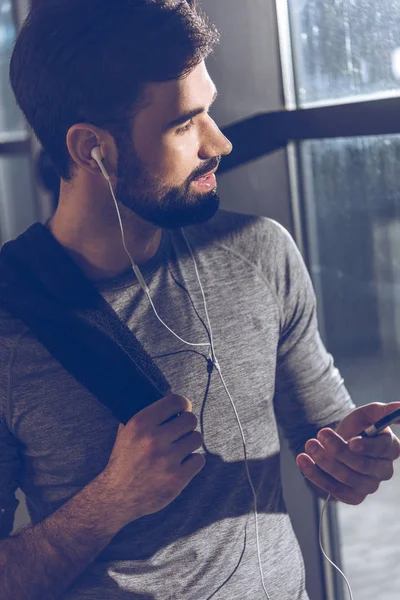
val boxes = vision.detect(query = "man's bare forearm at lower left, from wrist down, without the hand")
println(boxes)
[0,474,124,600]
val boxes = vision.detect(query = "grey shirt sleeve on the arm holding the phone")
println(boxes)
[274,224,355,454]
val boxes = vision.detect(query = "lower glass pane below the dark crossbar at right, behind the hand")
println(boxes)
[302,136,400,600]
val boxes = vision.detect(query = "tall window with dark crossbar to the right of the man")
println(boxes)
[217,0,400,600]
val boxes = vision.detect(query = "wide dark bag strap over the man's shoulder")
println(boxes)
[0,223,170,423]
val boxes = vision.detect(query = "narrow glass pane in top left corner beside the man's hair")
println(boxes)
[0,0,25,133]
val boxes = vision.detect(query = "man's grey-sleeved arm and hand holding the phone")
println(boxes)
[266,225,400,504]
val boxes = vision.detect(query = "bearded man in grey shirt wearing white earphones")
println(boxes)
[0,0,399,600]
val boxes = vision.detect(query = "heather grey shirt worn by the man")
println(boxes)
[0,211,353,600]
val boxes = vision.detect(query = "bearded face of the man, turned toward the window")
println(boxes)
[116,63,232,228]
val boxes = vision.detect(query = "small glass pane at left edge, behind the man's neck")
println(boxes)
[0,156,37,243]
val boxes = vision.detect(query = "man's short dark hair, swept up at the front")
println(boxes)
[10,0,218,180]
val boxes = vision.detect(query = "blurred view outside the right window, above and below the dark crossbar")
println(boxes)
[289,0,400,600]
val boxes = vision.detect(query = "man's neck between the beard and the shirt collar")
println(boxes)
[49,182,162,281]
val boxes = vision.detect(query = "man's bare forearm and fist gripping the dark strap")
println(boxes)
[0,394,205,600]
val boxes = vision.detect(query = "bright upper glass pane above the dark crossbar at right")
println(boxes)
[289,0,400,106]
